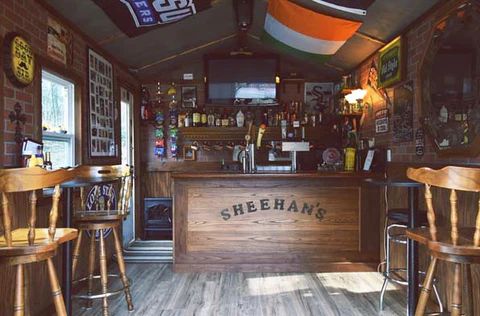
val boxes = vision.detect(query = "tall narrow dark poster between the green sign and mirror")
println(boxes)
[392,80,413,143]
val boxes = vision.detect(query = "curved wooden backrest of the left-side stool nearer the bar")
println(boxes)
[75,165,133,214]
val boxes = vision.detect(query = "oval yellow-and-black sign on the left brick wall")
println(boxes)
[3,32,35,88]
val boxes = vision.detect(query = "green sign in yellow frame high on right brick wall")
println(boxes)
[378,36,404,88]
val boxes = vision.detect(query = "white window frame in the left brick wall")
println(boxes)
[40,69,76,167]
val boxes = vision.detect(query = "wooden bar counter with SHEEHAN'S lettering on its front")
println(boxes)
[173,172,379,272]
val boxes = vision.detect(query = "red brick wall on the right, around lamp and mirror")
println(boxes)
[357,1,480,163]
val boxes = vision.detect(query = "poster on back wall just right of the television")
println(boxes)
[305,82,333,113]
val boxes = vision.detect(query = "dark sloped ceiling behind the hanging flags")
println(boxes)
[43,0,443,80]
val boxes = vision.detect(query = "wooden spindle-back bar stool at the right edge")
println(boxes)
[407,167,480,316]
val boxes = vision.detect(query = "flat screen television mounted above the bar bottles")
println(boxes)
[205,55,278,106]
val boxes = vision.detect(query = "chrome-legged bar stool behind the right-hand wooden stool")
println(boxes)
[380,208,443,313]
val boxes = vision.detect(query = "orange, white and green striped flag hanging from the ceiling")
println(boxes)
[262,0,361,62]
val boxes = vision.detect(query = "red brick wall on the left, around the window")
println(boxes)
[0,0,138,166]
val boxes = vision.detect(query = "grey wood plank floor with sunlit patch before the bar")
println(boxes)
[74,264,406,316]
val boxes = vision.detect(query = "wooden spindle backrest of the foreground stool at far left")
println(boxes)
[0,167,75,247]
